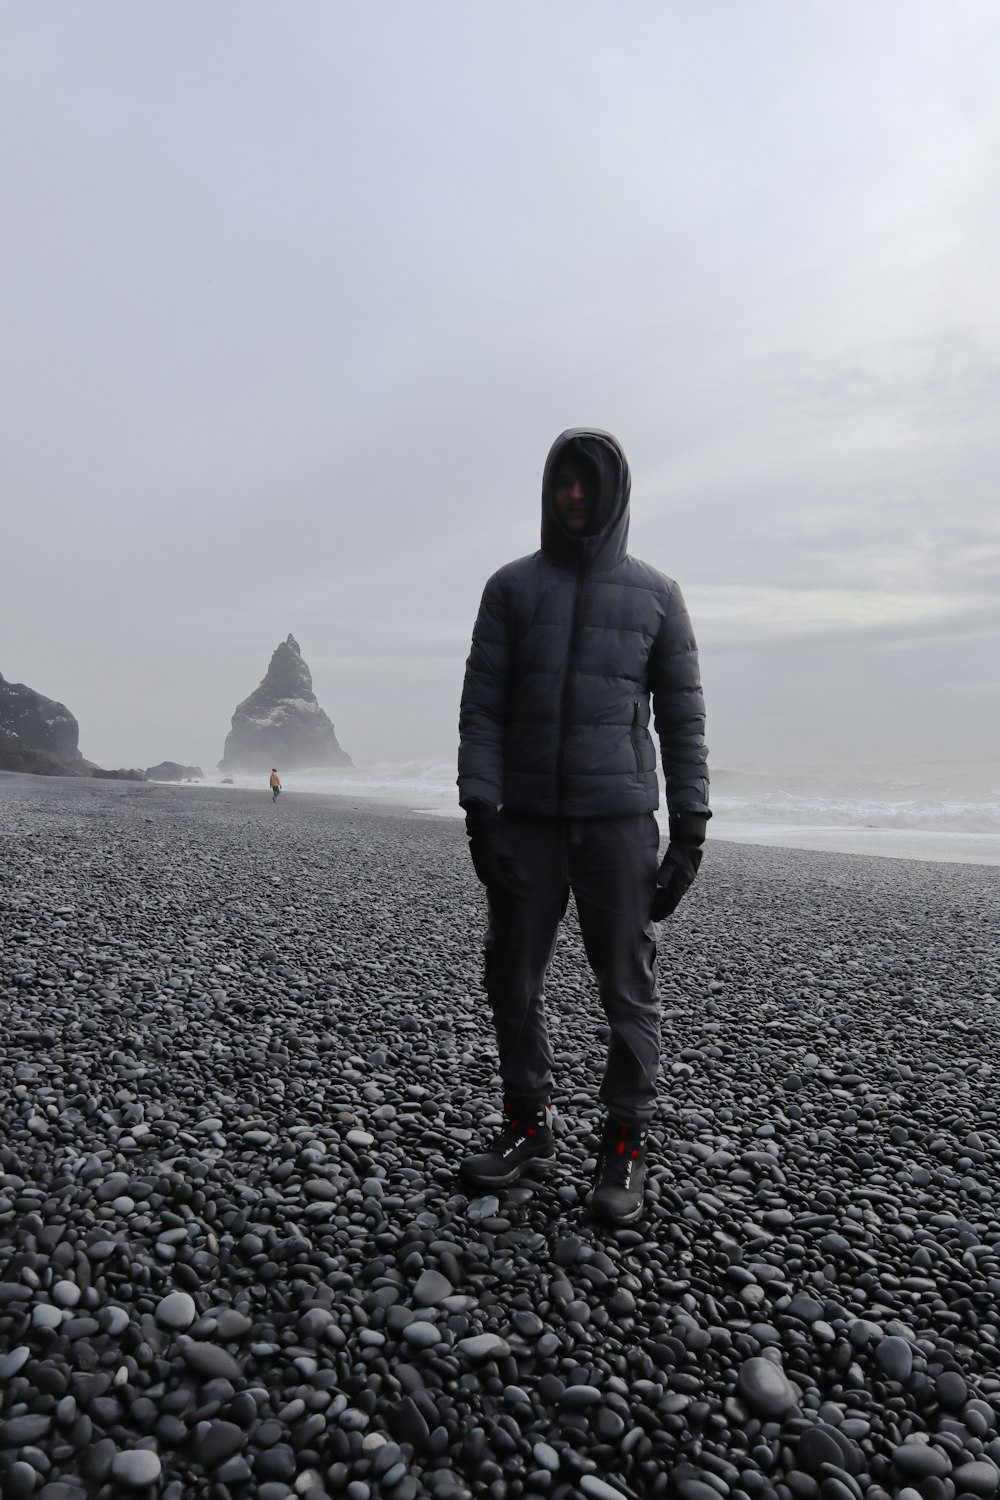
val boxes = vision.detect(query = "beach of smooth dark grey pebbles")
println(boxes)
[0,774,1000,1500]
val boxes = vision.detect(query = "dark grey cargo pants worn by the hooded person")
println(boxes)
[486,813,660,1121]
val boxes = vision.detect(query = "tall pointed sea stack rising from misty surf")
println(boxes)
[219,635,352,773]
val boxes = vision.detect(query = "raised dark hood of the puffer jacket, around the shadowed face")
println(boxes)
[541,428,631,570]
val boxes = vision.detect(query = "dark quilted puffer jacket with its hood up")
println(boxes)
[459,428,709,818]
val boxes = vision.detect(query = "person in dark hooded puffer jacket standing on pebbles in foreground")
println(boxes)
[459,429,711,1223]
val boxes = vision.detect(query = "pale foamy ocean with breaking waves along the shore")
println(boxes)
[197,759,1000,864]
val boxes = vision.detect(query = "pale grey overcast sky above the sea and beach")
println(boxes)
[0,0,1000,770]
